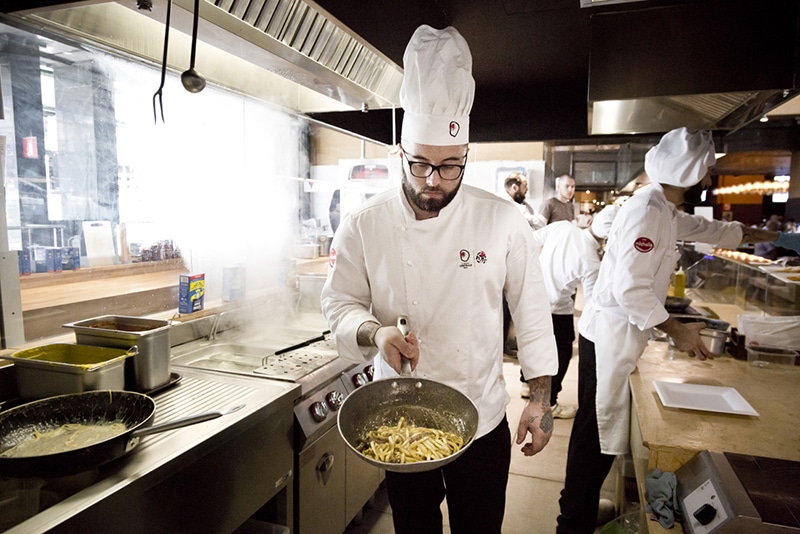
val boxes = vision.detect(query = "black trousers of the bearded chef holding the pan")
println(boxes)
[386,417,511,534]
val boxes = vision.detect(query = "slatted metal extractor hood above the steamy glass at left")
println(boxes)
[7,0,402,112]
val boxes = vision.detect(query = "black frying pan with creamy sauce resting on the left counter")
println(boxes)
[0,390,244,477]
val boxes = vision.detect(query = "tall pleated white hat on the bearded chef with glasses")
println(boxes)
[400,24,475,146]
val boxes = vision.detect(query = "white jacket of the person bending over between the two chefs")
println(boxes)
[533,221,600,315]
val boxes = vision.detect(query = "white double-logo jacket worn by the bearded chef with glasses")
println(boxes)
[321,184,558,437]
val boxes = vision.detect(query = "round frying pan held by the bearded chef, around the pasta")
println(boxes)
[338,317,478,473]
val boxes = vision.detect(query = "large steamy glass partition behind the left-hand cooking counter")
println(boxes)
[0,24,310,341]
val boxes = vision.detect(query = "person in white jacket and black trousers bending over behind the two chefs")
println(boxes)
[522,205,619,419]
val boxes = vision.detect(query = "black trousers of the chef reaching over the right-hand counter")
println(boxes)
[556,336,614,534]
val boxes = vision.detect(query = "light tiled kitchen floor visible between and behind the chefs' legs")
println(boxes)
[345,343,614,534]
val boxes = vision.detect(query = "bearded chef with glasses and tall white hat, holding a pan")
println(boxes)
[322,25,558,534]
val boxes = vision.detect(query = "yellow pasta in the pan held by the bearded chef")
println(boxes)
[357,417,464,464]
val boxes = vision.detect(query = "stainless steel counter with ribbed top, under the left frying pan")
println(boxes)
[7,369,300,534]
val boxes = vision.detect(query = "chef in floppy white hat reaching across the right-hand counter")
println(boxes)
[556,128,800,534]
